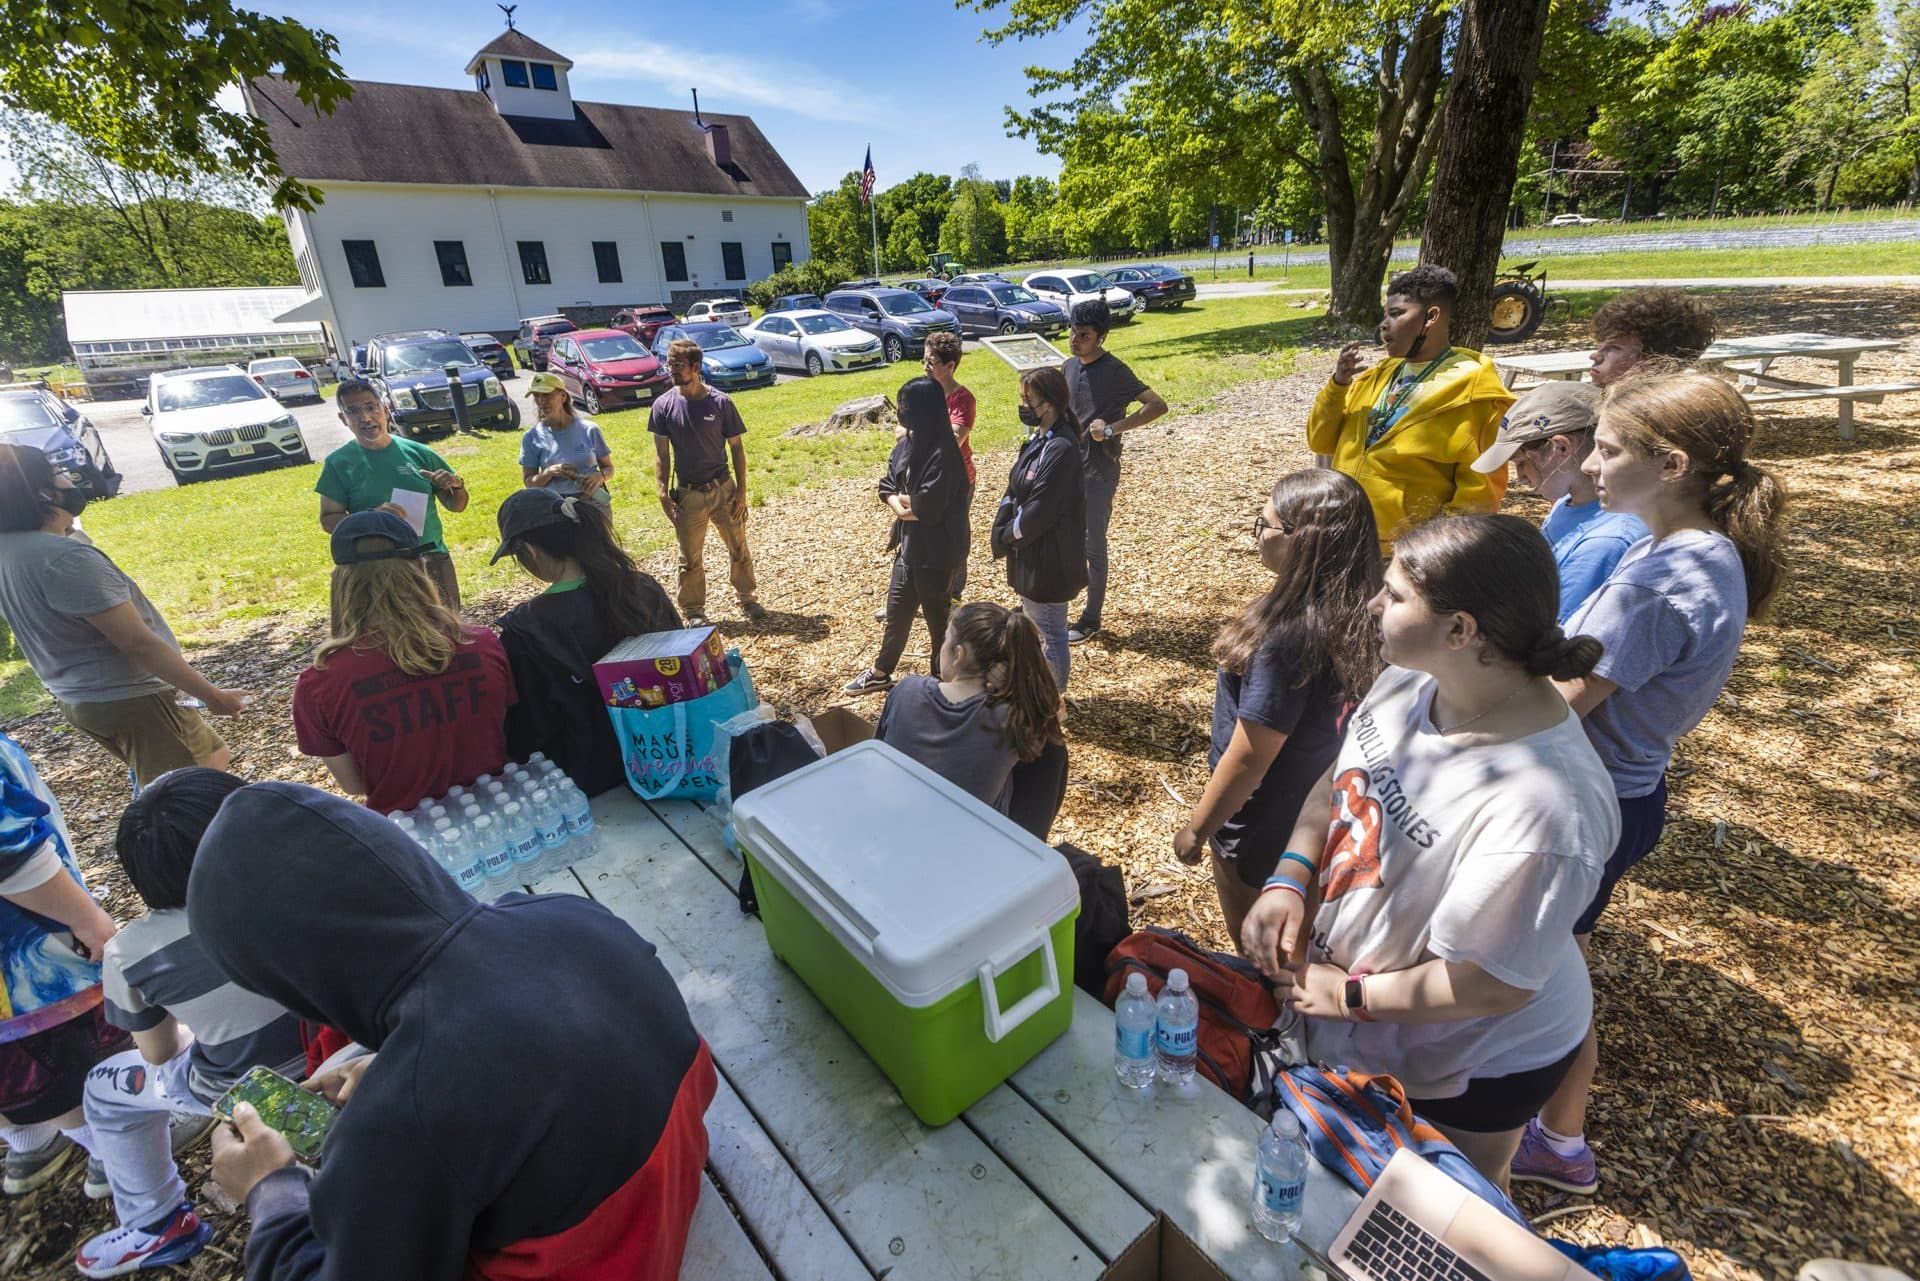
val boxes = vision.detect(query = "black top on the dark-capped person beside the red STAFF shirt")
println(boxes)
[499,574,680,797]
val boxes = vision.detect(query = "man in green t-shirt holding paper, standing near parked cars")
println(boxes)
[313,378,467,609]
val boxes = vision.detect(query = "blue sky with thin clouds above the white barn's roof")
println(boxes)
[284,0,1081,192]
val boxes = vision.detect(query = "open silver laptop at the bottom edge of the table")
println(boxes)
[1294,1148,1594,1281]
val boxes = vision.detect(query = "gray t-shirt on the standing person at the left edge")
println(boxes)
[0,530,179,703]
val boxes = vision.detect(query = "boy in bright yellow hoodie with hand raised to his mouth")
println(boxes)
[1308,267,1513,553]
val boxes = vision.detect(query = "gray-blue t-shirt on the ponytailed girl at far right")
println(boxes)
[1565,530,1747,797]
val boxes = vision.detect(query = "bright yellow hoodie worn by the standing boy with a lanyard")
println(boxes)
[1308,348,1513,553]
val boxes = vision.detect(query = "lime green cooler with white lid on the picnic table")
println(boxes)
[733,741,1079,1125]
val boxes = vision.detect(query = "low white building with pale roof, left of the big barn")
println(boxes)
[60,288,326,398]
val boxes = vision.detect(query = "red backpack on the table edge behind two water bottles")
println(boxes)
[1102,926,1281,1112]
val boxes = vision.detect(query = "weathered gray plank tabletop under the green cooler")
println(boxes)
[532,789,1359,1281]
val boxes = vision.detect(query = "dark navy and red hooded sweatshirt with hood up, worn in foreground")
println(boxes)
[186,784,716,1281]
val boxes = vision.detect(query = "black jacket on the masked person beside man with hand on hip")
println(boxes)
[993,423,1087,605]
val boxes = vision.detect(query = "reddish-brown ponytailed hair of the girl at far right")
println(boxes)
[1601,371,1788,618]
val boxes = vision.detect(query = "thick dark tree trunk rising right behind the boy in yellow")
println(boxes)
[1421,0,1548,348]
